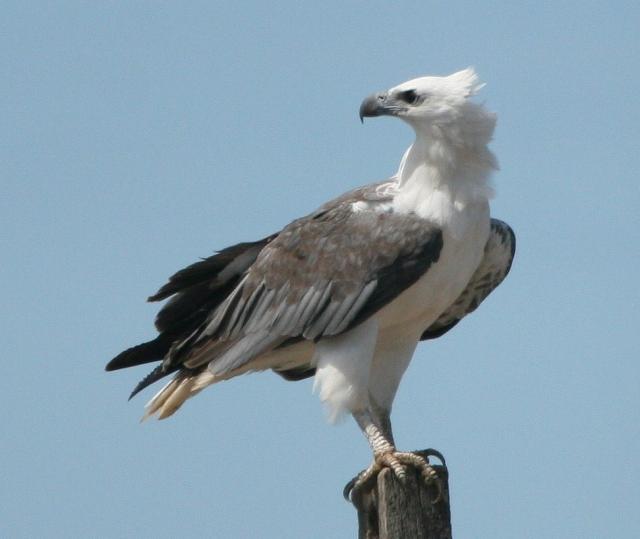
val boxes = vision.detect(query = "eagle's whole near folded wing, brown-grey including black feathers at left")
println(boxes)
[107,186,442,394]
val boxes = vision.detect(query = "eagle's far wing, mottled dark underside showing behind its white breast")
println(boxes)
[420,219,516,341]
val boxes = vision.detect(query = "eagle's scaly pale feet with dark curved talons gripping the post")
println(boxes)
[342,450,444,503]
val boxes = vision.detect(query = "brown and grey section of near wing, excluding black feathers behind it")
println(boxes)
[167,193,442,380]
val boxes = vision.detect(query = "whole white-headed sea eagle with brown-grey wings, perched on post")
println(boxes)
[106,68,515,498]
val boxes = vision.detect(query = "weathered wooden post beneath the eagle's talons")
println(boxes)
[353,450,451,539]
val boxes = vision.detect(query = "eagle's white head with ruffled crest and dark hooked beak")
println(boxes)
[360,67,496,147]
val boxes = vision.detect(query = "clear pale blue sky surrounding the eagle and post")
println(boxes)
[0,1,640,539]
